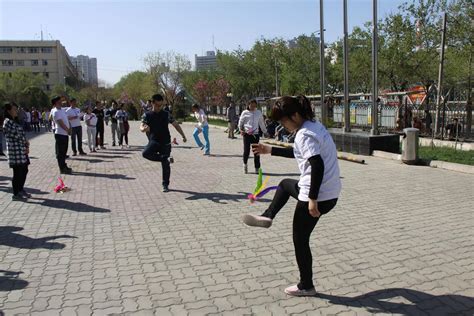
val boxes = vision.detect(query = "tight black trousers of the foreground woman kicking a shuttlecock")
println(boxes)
[262,179,337,290]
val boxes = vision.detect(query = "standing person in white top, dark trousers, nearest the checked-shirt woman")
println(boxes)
[51,97,72,174]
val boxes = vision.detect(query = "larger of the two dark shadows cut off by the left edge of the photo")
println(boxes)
[0,226,77,249]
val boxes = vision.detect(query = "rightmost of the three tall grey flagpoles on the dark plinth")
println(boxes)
[370,0,379,135]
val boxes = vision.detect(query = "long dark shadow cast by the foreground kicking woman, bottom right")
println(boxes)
[316,288,474,316]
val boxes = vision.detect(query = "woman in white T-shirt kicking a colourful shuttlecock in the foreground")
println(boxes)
[242,96,341,296]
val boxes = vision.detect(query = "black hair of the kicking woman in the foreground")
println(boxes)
[271,95,314,121]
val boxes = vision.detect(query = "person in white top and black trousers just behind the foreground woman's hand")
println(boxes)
[239,100,267,174]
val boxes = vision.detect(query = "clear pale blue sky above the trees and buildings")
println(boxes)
[0,0,404,85]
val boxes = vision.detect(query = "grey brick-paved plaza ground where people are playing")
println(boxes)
[0,122,474,316]
